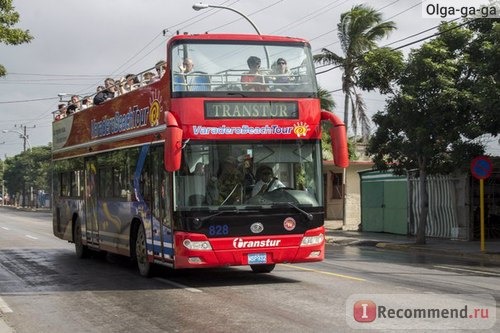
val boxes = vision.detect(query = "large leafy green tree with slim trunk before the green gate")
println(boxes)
[367,20,500,244]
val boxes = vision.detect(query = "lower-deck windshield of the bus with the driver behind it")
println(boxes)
[174,140,323,210]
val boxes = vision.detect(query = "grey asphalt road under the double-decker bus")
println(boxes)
[0,208,500,333]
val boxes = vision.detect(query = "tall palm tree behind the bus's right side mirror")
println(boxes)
[314,5,396,138]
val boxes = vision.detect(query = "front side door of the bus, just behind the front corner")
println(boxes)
[151,147,173,261]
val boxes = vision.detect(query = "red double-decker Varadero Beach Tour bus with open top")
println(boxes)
[52,34,348,276]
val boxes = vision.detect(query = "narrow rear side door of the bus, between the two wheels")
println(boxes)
[85,157,99,247]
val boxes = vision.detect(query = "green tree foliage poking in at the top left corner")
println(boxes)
[0,0,33,77]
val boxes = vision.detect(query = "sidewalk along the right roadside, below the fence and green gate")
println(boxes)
[325,221,500,264]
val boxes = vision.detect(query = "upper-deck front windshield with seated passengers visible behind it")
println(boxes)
[171,41,317,97]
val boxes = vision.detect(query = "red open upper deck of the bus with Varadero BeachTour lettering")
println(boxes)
[53,34,321,158]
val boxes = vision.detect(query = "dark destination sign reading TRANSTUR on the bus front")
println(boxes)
[205,101,299,119]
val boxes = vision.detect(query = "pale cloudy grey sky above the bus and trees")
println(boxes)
[0,0,500,159]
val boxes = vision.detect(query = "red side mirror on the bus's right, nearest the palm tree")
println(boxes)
[321,110,349,168]
